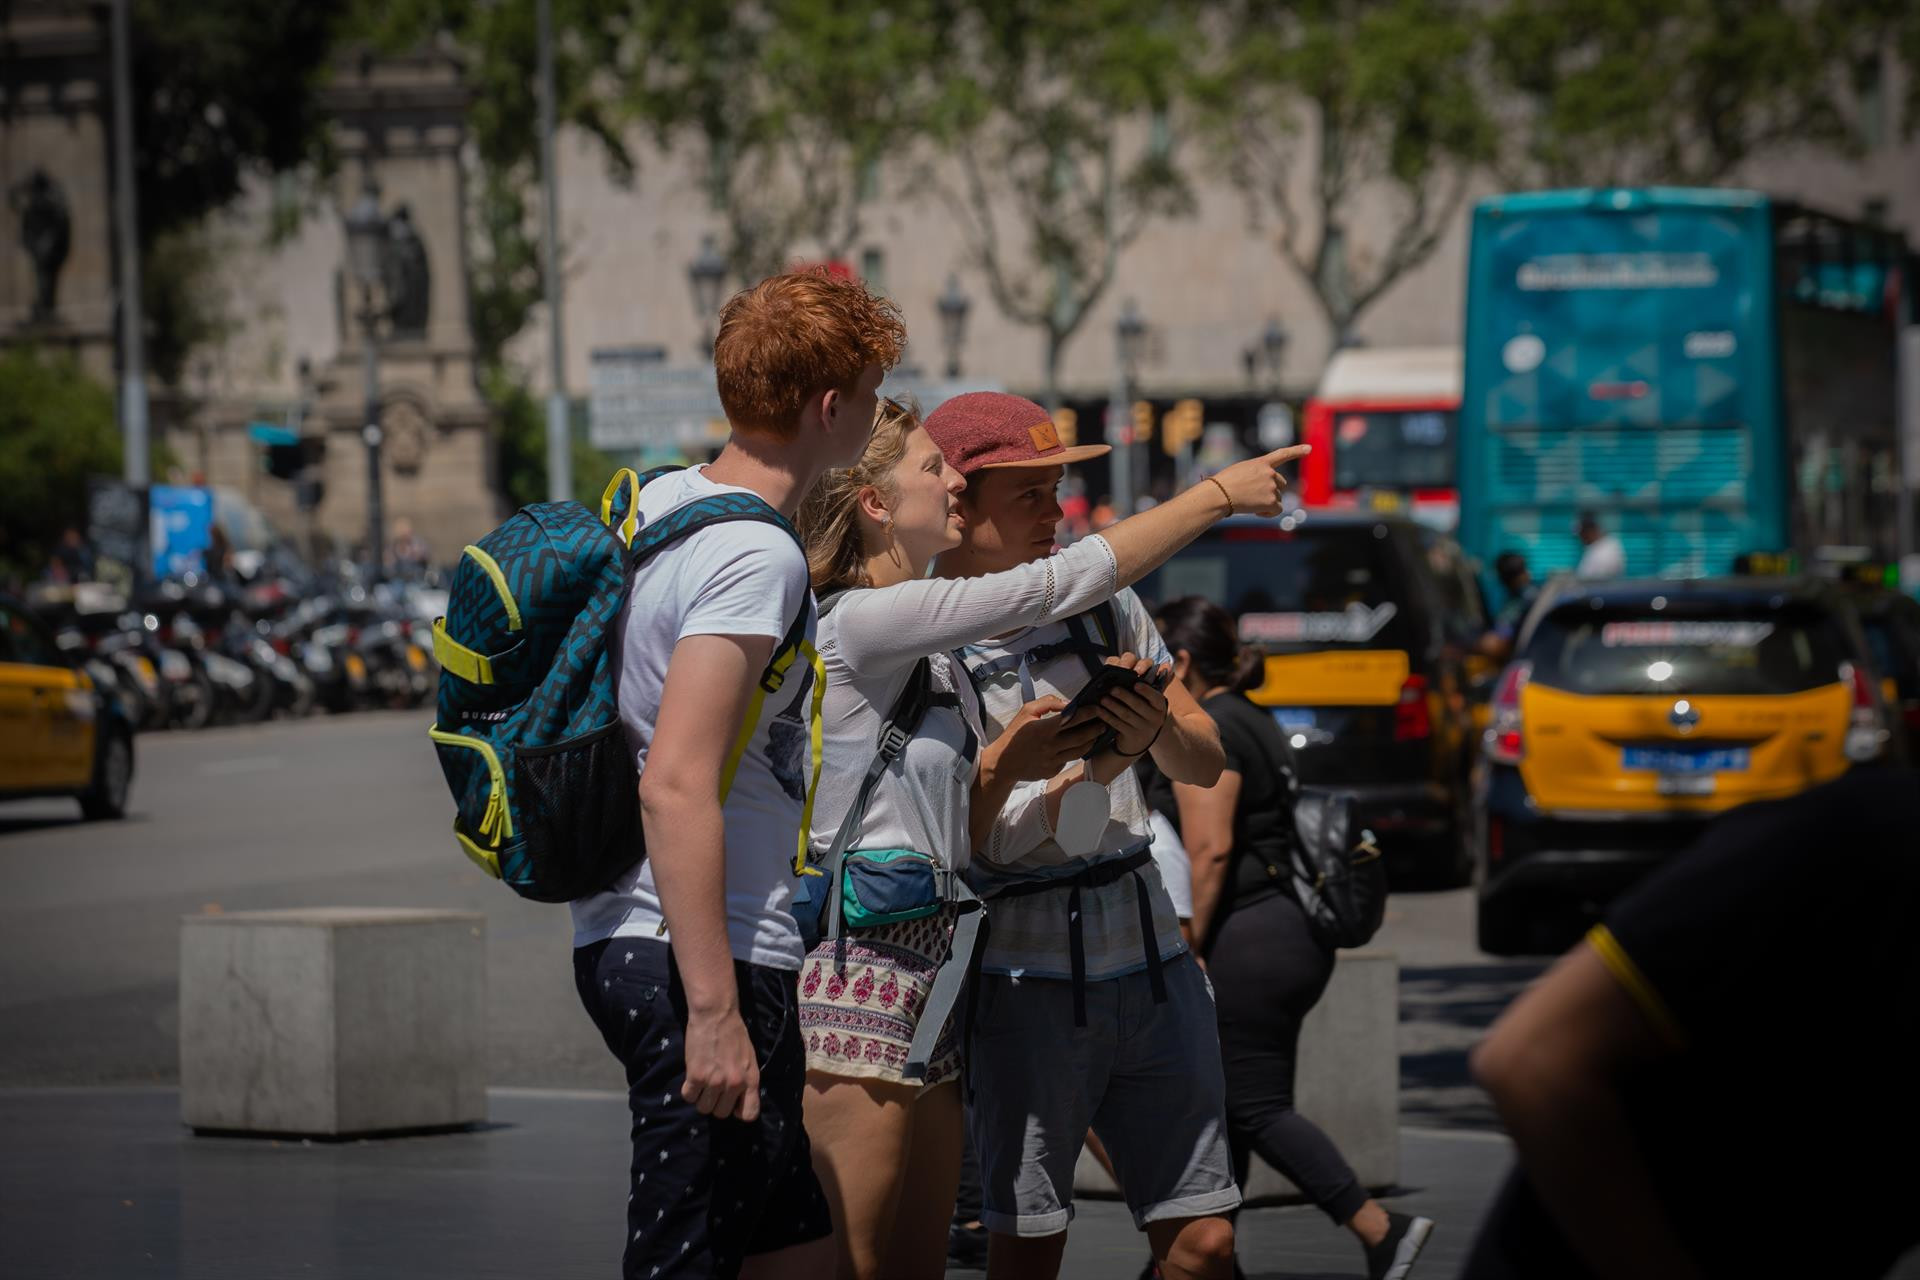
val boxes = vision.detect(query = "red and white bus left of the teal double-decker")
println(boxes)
[1300,347,1461,532]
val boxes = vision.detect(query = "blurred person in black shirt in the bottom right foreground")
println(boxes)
[1463,768,1920,1280]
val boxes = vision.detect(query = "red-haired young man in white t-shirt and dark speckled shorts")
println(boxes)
[572,273,906,1280]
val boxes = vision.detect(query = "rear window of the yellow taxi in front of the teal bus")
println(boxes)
[1523,604,1847,695]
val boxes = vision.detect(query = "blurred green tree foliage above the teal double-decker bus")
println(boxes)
[1488,0,1920,186]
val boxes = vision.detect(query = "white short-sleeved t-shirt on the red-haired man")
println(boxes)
[572,468,814,969]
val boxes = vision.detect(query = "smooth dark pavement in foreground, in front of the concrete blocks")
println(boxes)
[0,1088,1509,1280]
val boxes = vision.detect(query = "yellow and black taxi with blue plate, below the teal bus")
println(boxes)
[1475,578,1899,956]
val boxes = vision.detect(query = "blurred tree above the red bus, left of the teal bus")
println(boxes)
[1192,0,1496,338]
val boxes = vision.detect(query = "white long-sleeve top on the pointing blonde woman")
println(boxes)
[812,535,1117,871]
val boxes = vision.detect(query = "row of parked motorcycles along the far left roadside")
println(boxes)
[38,572,445,731]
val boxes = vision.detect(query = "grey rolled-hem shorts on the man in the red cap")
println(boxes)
[968,956,1240,1236]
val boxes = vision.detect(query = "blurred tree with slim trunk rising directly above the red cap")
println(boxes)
[922,0,1200,407]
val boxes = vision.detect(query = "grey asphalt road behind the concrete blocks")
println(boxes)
[0,712,1538,1126]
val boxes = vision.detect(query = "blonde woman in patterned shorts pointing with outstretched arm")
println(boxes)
[799,395,1284,1280]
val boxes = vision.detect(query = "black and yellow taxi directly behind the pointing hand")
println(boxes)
[1140,510,1488,883]
